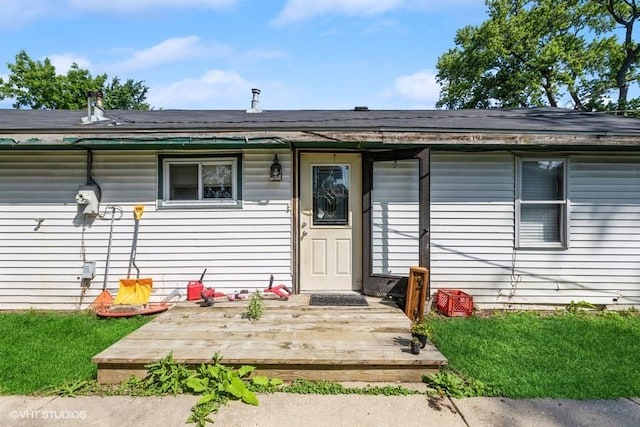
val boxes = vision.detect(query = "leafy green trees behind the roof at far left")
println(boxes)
[0,50,150,110]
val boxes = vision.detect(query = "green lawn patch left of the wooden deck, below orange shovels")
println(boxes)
[0,310,151,394]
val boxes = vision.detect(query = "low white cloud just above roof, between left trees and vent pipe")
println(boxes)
[147,70,252,109]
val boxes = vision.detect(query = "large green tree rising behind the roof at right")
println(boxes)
[436,0,638,110]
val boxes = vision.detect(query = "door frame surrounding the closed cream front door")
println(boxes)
[291,147,364,294]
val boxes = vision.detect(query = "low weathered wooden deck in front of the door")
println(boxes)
[91,295,447,383]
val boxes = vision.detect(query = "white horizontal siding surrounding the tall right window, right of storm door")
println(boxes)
[431,153,640,308]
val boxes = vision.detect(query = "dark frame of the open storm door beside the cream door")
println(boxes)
[362,147,431,296]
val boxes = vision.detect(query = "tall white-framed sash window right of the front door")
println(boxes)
[516,157,569,249]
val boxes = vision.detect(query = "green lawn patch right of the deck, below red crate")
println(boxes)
[429,312,640,399]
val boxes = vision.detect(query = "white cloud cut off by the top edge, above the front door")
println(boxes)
[273,0,405,25]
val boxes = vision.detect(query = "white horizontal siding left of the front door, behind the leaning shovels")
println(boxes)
[0,150,292,309]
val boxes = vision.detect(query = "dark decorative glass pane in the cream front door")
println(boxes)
[312,165,349,225]
